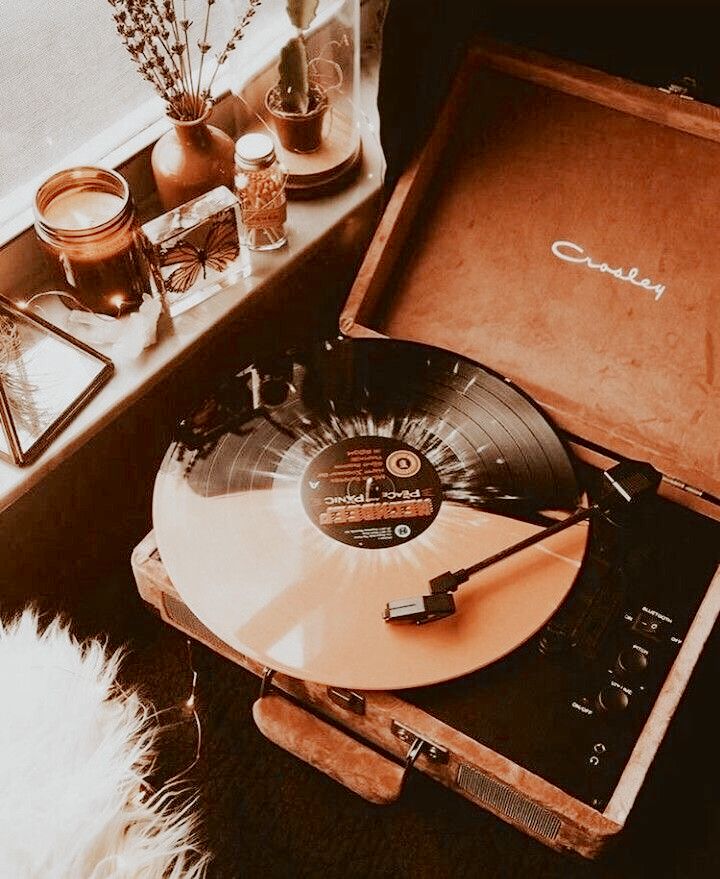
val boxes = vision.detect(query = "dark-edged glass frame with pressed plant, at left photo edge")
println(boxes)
[0,296,114,466]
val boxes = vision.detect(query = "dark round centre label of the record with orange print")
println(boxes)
[301,436,443,549]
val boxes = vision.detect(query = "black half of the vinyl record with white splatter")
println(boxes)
[173,338,578,510]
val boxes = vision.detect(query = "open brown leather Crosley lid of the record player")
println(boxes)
[341,39,720,496]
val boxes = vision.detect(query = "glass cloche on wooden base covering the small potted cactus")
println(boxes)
[237,0,360,196]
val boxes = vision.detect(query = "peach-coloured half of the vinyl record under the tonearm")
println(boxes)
[153,461,588,690]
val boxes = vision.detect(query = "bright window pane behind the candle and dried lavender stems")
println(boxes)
[0,0,268,237]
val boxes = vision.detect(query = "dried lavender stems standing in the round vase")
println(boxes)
[108,0,262,121]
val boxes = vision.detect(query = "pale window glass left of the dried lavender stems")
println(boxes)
[0,0,144,222]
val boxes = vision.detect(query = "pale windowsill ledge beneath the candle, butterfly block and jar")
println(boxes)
[0,130,384,512]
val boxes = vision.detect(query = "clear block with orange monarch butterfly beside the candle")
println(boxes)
[143,186,250,317]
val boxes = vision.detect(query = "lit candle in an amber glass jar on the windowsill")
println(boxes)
[35,167,150,317]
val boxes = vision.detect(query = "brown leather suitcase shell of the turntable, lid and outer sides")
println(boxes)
[133,44,720,857]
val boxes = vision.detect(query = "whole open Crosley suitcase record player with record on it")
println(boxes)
[133,44,720,857]
